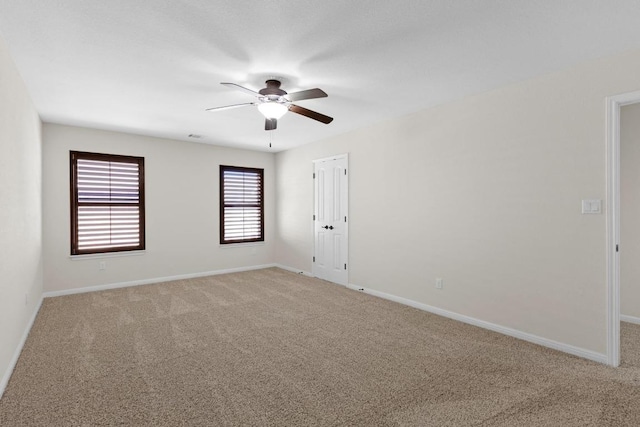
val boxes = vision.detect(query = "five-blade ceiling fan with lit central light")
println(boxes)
[206,79,333,130]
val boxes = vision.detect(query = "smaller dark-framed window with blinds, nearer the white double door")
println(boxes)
[220,165,264,244]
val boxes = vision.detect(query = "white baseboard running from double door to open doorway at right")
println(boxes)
[347,284,608,365]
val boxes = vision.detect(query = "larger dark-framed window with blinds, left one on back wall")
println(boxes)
[70,151,145,255]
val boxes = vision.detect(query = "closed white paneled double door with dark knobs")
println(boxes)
[313,154,349,286]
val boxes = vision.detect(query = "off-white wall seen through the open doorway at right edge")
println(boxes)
[620,104,640,319]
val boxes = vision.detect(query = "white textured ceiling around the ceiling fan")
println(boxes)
[0,0,640,151]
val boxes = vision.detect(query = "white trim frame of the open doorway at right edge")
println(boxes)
[606,91,640,367]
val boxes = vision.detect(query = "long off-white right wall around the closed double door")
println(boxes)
[276,46,640,354]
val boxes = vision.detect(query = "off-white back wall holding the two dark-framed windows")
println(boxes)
[43,124,275,292]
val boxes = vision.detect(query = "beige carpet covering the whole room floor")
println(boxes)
[0,269,640,426]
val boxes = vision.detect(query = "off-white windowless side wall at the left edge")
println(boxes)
[0,39,42,394]
